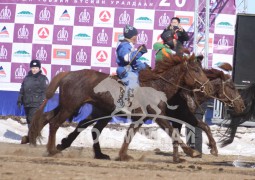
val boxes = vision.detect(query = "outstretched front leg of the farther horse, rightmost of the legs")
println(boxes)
[197,120,218,156]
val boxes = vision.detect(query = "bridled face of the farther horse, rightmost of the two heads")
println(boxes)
[218,78,245,113]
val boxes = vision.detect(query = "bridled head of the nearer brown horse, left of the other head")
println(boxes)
[184,54,213,95]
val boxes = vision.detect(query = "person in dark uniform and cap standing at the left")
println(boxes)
[17,60,49,144]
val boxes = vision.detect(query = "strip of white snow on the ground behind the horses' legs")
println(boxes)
[0,119,255,156]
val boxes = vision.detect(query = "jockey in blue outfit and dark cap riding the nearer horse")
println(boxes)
[116,25,147,111]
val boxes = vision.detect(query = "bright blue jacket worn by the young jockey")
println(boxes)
[116,42,142,66]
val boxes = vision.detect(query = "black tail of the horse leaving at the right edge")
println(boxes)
[221,83,255,147]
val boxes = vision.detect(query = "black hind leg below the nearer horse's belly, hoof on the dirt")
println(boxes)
[92,118,111,160]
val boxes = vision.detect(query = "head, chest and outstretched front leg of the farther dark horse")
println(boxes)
[167,69,245,158]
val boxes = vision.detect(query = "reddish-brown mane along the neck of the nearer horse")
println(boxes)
[139,52,192,82]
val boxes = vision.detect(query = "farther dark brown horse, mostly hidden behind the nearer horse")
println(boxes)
[53,65,244,162]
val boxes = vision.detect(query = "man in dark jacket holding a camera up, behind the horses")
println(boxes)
[161,17,189,55]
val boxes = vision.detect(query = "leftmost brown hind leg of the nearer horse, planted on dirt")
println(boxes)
[47,109,72,155]
